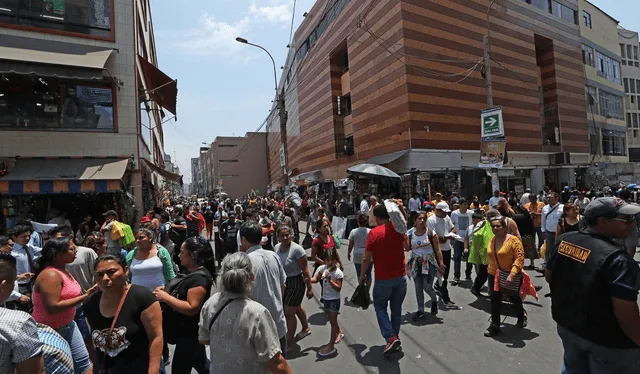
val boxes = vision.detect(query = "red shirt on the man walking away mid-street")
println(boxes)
[366,223,406,281]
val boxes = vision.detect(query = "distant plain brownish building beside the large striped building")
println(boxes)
[204,132,269,198]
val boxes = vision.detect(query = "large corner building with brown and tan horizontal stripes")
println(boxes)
[267,0,590,194]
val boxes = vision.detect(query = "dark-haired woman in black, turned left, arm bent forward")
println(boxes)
[153,237,216,374]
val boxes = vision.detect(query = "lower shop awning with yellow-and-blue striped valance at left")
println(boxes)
[0,158,129,195]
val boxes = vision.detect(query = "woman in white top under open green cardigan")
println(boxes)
[127,227,176,291]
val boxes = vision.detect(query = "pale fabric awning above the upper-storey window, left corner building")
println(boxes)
[0,35,113,80]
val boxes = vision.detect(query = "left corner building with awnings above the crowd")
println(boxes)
[0,0,179,220]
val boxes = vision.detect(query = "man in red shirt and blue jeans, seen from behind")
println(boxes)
[360,202,407,353]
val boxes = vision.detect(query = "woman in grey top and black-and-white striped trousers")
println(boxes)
[274,226,313,351]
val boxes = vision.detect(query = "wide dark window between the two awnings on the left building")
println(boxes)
[0,74,115,131]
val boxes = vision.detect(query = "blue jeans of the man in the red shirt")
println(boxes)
[373,275,407,341]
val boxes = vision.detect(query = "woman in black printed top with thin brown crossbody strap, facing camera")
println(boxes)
[84,255,162,374]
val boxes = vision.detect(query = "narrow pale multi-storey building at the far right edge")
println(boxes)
[618,28,640,162]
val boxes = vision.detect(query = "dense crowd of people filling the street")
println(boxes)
[0,188,640,374]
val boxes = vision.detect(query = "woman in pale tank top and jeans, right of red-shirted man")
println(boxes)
[404,212,445,321]
